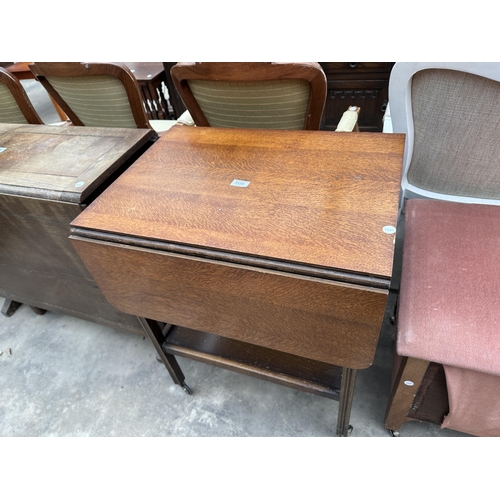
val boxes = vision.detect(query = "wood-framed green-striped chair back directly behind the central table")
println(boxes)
[171,62,327,130]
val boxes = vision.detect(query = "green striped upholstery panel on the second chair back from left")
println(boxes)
[46,75,137,128]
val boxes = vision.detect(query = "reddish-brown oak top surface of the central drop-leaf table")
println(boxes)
[72,127,404,277]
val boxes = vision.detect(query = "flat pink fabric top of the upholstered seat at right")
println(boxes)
[397,199,500,375]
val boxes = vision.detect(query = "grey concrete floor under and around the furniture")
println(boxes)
[0,82,466,441]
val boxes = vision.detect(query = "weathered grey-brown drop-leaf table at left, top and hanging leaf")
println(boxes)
[0,123,156,334]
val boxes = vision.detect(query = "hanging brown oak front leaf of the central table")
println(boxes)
[71,237,387,368]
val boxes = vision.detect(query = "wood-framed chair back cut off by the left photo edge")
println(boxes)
[0,67,43,125]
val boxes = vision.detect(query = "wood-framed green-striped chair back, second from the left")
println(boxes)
[29,62,151,128]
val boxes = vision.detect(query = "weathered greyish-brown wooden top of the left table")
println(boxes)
[0,123,154,203]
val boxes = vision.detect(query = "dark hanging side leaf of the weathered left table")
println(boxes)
[0,195,142,333]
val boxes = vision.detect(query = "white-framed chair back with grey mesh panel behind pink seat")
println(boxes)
[389,62,500,205]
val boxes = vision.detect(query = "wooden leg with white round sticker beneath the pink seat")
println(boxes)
[385,357,429,435]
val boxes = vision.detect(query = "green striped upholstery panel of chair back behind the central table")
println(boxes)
[188,79,311,130]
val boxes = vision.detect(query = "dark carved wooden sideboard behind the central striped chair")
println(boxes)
[163,62,395,132]
